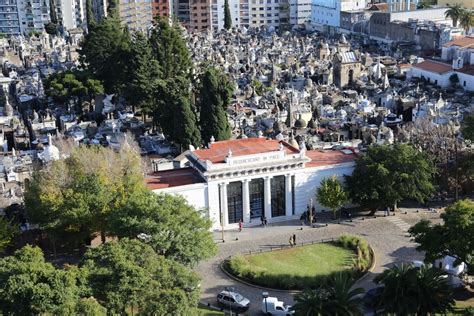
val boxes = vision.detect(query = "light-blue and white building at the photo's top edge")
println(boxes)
[311,0,367,29]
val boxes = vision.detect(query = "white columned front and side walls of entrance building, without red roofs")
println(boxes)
[153,140,354,230]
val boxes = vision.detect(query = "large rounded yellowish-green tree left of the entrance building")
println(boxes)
[25,146,145,244]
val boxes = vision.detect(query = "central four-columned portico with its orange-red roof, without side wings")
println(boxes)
[190,138,309,227]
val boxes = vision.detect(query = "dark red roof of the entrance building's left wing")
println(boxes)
[145,168,204,190]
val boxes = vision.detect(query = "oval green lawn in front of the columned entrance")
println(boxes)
[226,243,356,289]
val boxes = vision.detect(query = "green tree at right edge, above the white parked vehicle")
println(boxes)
[409,200,474,267]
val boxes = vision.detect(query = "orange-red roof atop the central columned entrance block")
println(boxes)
[193,138,299,163]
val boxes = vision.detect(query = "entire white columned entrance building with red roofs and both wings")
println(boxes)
[147,138,356,229]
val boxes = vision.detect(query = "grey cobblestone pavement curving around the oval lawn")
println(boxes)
[197,208,440,315]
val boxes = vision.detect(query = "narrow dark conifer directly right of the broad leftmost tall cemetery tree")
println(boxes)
[125,32,161,113]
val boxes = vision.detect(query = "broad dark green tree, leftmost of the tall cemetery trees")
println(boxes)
[79,16,131,93]
